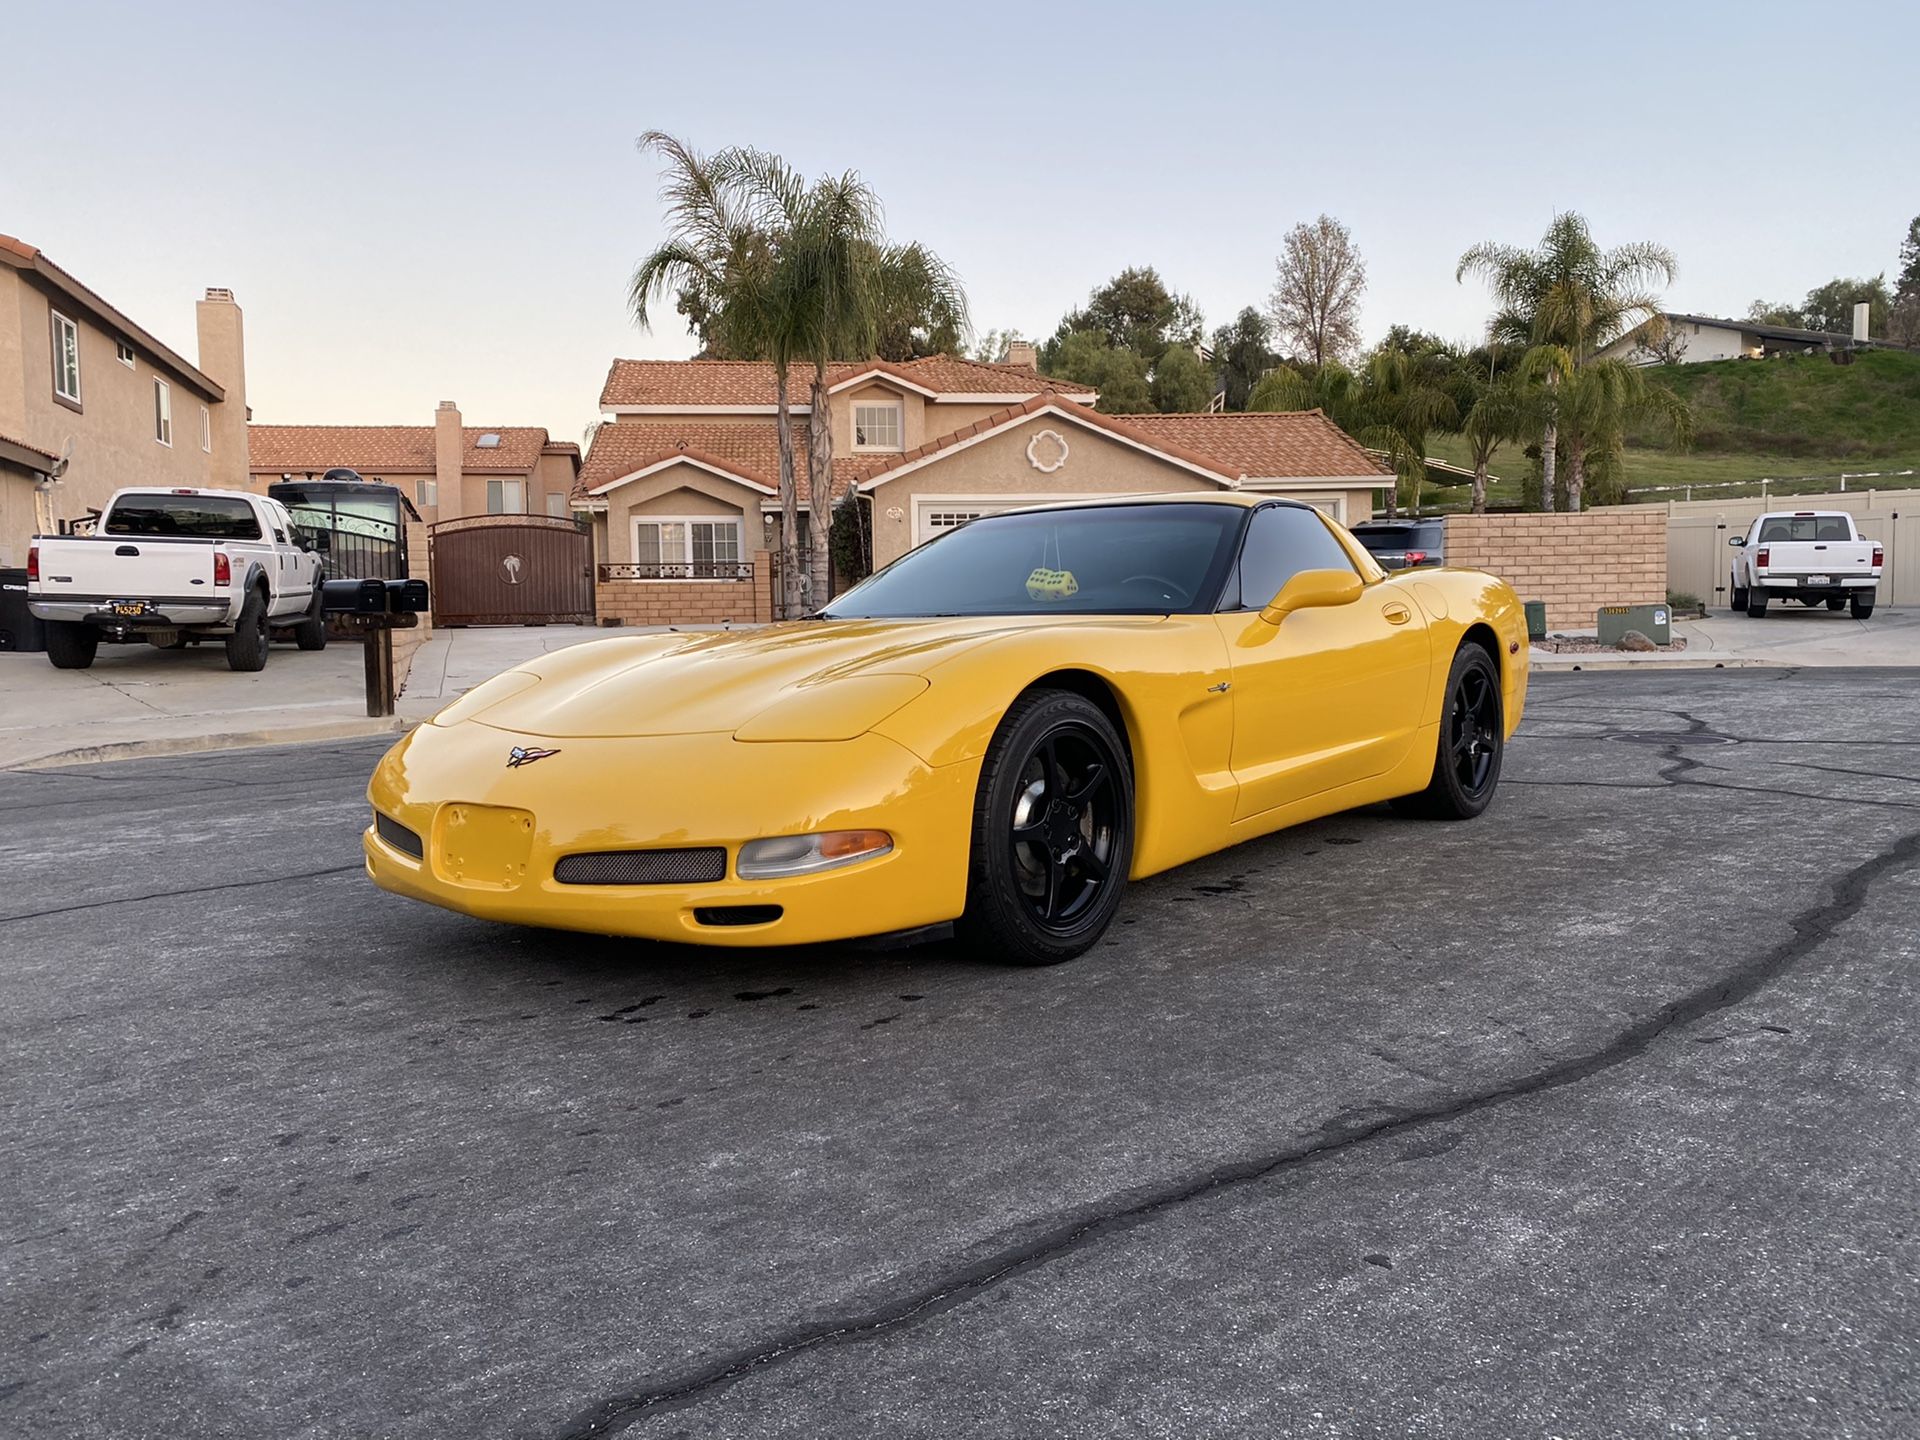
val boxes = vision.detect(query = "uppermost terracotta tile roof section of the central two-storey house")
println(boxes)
[601,355,1094,407]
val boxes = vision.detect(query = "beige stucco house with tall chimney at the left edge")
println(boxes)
[0,234,246,566]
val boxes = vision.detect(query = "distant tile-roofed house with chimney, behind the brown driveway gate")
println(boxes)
[248,399,580,524]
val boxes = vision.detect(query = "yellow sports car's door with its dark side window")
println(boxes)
[1215,505,1432,820]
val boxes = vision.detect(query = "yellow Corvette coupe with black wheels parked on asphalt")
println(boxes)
[365,493,1526,964]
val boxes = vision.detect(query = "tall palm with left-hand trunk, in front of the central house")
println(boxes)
[628,131,803,614]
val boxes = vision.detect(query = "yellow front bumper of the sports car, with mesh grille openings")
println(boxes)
[361,722,979,947]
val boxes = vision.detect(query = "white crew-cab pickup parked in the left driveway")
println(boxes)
[27,490,326,670]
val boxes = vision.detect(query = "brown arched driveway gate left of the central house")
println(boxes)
[426,515,593,626]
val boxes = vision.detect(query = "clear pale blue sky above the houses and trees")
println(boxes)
[0,0,1920,440]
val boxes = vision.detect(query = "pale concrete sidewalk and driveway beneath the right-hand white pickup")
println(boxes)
[1532,605,1920,670]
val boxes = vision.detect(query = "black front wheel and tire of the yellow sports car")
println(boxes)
[956,689,1133,966]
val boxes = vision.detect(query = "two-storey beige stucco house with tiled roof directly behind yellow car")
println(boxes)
[574,355,1392,624]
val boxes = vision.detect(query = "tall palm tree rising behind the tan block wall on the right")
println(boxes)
[1453,211,1678,511]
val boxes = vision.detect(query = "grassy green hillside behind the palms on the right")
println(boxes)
[1432,349,1920,505]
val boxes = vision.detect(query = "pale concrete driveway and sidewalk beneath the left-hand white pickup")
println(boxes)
[0,626,606,770]
